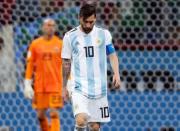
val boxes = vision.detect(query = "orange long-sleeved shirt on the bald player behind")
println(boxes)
[25,36,62,93]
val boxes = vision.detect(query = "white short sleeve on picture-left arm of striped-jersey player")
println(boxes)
[61,34,71,59]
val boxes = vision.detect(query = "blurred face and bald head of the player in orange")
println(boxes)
[42,20,56,36]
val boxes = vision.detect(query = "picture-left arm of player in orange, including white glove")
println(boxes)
[24,44,34,99]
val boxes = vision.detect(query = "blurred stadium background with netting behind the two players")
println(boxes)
[0,0,180,131]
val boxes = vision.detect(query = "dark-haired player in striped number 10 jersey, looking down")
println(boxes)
[61,3,120,131]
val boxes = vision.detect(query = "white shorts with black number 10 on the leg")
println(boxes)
[71,92,110,122]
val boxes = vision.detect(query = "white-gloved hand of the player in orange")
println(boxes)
[24,80,34,99]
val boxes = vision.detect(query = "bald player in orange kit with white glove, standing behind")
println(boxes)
[24,18,63,131]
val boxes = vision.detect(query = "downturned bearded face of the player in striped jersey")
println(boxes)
[80,15,96,34]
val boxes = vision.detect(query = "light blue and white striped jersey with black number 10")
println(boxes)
[62,26,115,98]
